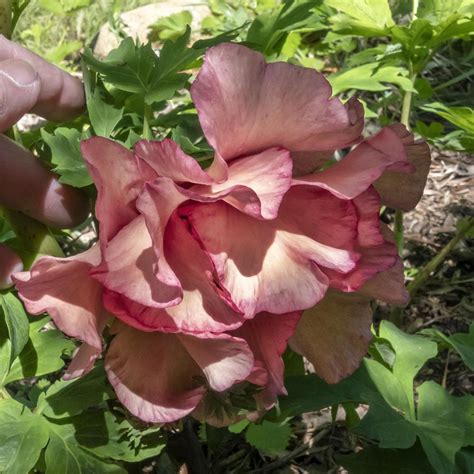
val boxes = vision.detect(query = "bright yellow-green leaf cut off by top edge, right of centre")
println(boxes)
[324,0,394,37]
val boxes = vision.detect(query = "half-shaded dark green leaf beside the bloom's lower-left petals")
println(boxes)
[38,366,109,418]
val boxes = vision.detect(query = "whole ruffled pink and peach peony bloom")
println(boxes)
[16,44,429,422]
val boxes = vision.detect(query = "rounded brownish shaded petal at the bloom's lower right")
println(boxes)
[290,290,372,383]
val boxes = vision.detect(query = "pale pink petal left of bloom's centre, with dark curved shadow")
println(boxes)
[91,215,182,308]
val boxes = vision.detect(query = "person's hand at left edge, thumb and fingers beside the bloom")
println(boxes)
[0,35,89,288]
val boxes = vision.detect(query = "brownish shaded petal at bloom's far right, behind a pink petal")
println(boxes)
[374,124,431,211]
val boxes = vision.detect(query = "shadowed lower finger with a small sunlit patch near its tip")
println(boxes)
[0,135,89,228]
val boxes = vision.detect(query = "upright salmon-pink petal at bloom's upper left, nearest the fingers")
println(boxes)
[81,137,143,249]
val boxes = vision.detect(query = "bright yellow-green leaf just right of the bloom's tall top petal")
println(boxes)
[328,63,416,95]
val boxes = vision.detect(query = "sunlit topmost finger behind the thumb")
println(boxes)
[0,35,85,121]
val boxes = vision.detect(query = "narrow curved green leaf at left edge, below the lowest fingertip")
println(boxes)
[0,293,29,366]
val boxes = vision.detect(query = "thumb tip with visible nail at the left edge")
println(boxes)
[0,59,41,131]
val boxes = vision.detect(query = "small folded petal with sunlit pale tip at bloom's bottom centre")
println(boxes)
[178,334,254,392]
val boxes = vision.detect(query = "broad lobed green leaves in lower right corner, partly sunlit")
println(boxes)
[280,321,474,474]
